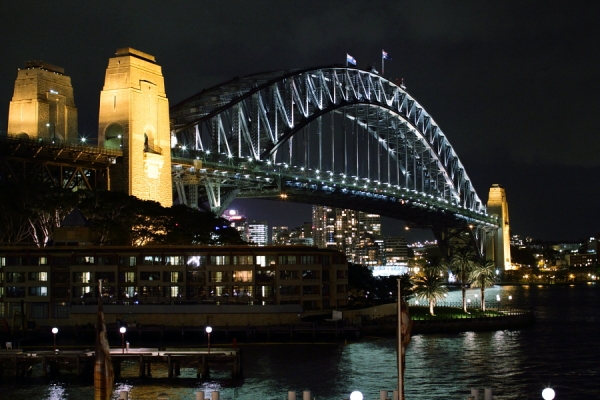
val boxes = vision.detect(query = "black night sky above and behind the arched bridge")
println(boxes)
[0,0,600,240]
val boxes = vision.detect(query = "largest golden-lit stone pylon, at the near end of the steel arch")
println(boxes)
[98,47,173,207]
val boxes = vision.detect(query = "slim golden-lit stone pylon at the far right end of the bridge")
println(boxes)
[487,184,512,270]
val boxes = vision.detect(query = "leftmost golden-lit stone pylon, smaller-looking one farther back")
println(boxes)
[8,61,78,142]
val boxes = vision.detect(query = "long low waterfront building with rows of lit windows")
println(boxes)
[0,244,348,326]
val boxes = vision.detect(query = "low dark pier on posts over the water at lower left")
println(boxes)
[0,348,242,379]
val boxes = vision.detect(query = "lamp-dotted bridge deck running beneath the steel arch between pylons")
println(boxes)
[172,156,498,229]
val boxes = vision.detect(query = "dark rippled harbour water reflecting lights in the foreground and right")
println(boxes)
[0,284,600,400]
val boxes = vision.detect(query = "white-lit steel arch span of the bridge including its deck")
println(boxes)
[170,67,497,231]
